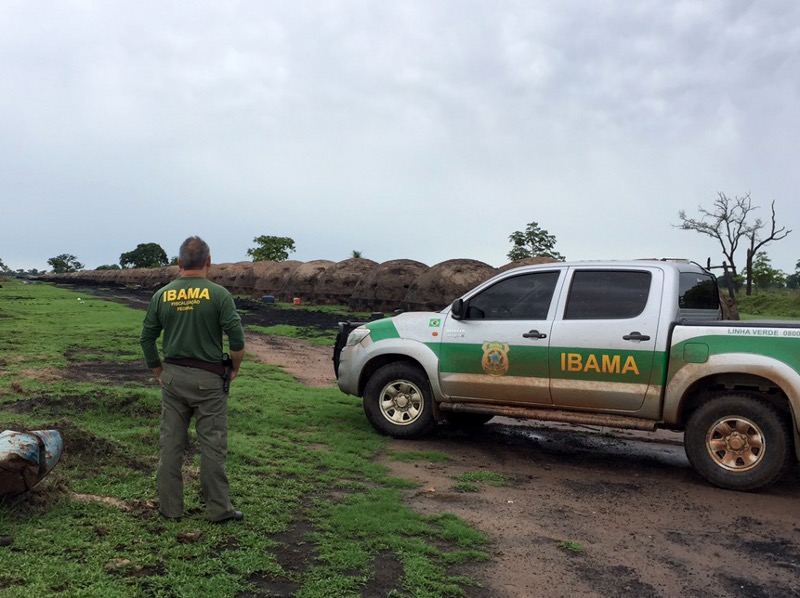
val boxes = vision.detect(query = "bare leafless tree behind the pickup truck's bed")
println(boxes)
[676,192,792,295]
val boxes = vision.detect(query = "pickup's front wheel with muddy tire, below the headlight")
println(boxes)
[364,363,436,438]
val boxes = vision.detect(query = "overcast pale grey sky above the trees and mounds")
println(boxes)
[0,0,800,273]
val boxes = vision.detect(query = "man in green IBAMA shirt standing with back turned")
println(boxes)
[141,237,244,523]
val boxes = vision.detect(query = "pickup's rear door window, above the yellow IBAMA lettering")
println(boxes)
[564,270,651,320]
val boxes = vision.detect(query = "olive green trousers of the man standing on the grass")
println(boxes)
[156,364,233,521]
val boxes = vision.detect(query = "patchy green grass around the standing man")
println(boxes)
[0,280,488,598]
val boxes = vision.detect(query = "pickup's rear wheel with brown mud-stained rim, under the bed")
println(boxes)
[684,393,792,491]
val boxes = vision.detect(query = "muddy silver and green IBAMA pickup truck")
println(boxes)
[333,260,800,491]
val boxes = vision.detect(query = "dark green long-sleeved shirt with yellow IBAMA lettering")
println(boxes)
[140,276,244,368]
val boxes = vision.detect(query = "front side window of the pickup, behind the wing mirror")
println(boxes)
[466,271,560,320]
